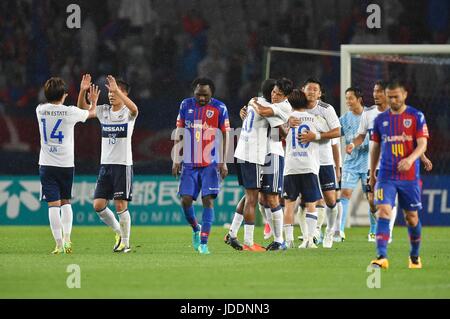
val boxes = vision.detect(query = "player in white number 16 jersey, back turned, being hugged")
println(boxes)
[283,89,328,248]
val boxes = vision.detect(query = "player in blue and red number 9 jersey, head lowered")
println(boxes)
[172,78,230,254]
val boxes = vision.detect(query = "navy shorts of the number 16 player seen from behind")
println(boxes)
[283,173,322,203]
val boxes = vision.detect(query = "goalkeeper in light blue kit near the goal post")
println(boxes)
[339,87,369,238]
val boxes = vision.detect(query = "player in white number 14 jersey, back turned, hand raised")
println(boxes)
[36,77,98,254]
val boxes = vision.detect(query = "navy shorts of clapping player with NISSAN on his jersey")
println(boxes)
[94,164,133,202]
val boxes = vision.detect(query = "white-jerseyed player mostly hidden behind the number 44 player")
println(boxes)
[345,80,432,243]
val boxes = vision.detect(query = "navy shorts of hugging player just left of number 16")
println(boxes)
[260,154,284,194]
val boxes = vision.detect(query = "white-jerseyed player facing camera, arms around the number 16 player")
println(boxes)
[289,78,341,248]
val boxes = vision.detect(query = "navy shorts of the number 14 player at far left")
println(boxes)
[39,166,75,202]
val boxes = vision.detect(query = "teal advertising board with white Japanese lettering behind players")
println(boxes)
[0,175,243,225]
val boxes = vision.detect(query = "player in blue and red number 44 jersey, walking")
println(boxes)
[370,81,429,268]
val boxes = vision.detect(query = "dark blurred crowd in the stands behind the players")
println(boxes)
[0,0,450,174]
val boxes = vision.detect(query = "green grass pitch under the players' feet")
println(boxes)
[0,226,450,299]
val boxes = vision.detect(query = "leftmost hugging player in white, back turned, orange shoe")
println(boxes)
[224,79,276,251]
